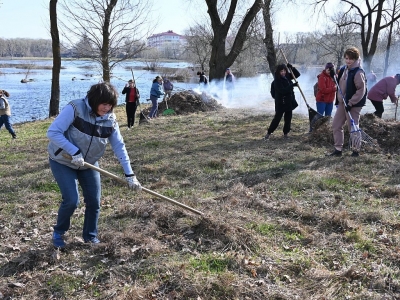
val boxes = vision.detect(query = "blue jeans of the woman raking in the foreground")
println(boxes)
[49,159,101,241]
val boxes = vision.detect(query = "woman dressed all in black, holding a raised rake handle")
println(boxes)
[264,63,300,140]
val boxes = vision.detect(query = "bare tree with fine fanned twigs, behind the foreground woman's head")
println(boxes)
[62,0,151,81]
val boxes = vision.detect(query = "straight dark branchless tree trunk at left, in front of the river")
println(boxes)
[49,0,61,117]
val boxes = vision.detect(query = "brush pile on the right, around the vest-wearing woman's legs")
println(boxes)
[309,113,400,153]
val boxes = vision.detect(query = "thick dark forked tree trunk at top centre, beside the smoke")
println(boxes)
[205,0,262,80]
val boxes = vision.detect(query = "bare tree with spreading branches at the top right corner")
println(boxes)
[314,0,400,72]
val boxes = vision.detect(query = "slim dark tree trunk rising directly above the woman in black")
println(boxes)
[262,0,276,73]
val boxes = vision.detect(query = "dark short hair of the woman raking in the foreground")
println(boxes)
[87,82,118,112]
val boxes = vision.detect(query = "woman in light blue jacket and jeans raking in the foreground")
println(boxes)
[47,82,142,248]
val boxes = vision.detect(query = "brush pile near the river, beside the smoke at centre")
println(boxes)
[141,90,222,115]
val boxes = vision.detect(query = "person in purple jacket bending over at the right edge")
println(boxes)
[368,74,400,118]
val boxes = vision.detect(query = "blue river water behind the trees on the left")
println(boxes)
[0,59,202,123]
